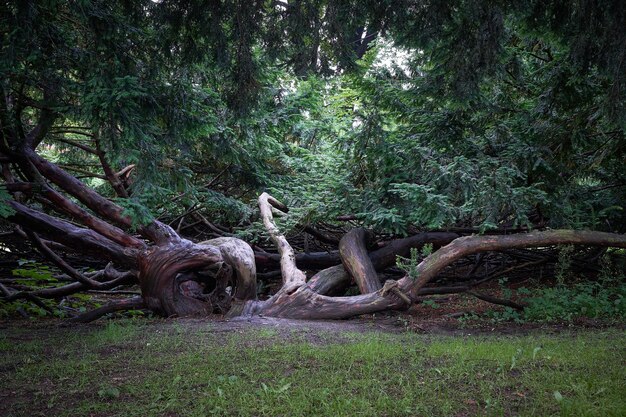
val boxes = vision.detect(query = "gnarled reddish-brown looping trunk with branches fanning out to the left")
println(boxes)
[0,133,256,316]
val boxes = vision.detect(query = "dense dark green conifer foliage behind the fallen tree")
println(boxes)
[0,0,626,320]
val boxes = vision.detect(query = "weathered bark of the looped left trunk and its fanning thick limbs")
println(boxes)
[5,147,256,316]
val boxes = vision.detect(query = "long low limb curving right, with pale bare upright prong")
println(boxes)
[230,200,626,319]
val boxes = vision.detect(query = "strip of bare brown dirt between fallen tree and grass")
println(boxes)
[0,294,626,342]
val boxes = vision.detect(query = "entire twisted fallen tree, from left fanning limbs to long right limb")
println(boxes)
[2,141,626,319]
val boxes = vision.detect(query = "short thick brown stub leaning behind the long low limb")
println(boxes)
[339,228,382,294]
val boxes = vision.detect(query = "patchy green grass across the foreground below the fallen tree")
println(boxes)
[0,320,626,416]
